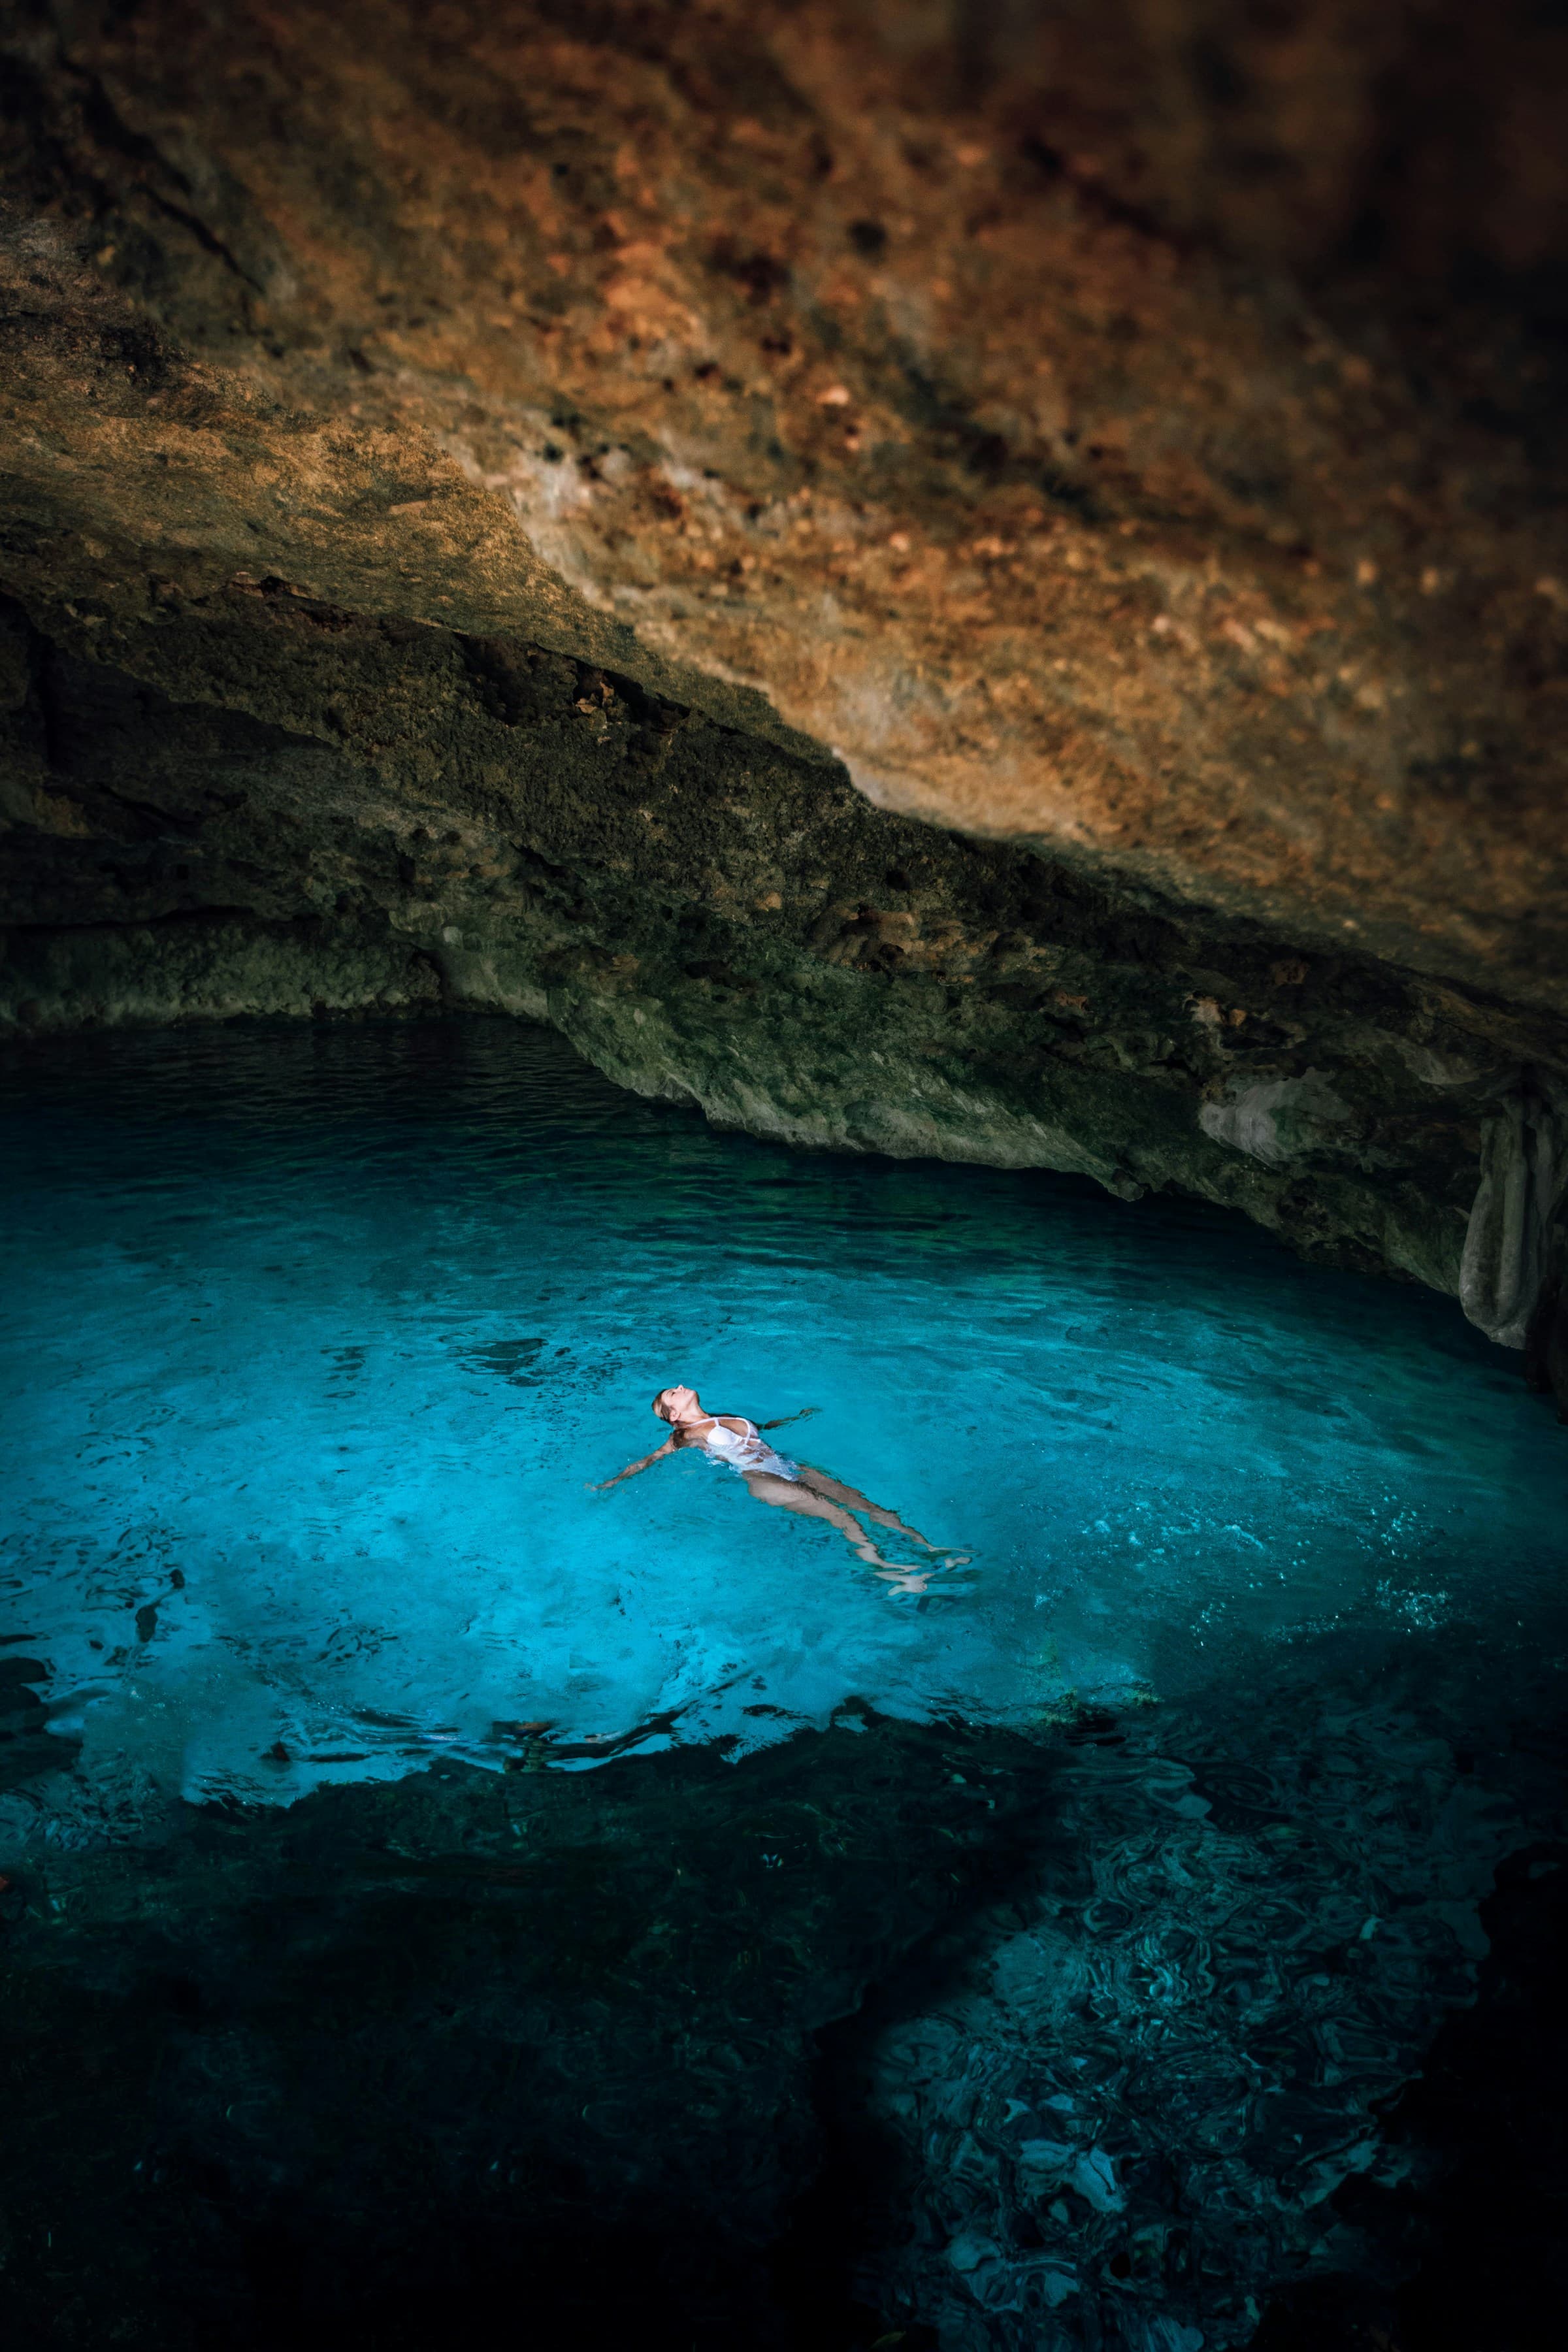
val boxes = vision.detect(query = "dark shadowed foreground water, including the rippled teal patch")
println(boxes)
[0,1686,1568,2352]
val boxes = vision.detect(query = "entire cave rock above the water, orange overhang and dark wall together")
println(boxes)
[0,0,1568,1338]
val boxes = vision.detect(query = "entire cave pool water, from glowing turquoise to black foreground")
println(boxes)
[0,1021,1568,2352]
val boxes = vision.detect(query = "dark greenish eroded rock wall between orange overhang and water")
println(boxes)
[12,585,1556,1343]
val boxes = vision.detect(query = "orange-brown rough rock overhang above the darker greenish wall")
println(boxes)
[12,0,1568,1004]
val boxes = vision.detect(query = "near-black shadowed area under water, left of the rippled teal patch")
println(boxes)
[0,1708,1071,2352]
